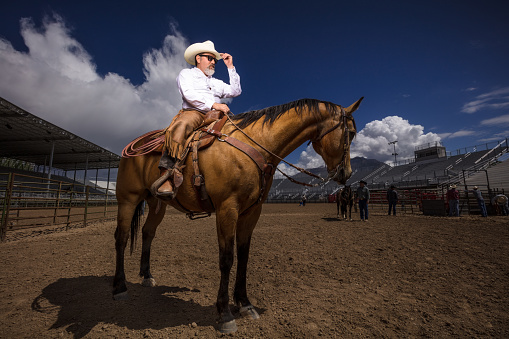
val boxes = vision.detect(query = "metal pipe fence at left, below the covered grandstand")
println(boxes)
[0,173,117,241]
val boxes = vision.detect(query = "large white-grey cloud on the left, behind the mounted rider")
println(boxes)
[0,15,188,153]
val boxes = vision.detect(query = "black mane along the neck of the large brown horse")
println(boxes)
[232,99,339,128]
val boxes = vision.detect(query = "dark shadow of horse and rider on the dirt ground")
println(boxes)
[32,276,216,338]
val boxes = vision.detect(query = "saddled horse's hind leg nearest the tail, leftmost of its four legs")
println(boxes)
[113,200,141,300]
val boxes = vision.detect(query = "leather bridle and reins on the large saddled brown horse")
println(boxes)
[227,106,357,187]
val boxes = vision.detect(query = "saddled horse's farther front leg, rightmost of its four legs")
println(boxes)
[233,204,262,319]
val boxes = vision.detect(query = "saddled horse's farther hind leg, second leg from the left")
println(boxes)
[140,197,166,287]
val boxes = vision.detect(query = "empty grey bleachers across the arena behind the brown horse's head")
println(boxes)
[269,141,509,201]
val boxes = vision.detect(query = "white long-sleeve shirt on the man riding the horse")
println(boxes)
[177,67,242,112]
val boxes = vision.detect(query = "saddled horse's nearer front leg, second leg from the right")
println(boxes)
[216,203,239,333]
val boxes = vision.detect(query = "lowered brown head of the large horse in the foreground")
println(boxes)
[312,98,364,184]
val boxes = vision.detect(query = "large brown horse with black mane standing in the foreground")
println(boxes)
[113,98,363,333]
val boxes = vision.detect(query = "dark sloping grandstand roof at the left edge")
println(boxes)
[0,97,121,170]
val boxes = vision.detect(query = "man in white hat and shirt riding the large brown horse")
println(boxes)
[153,41,242,199]
